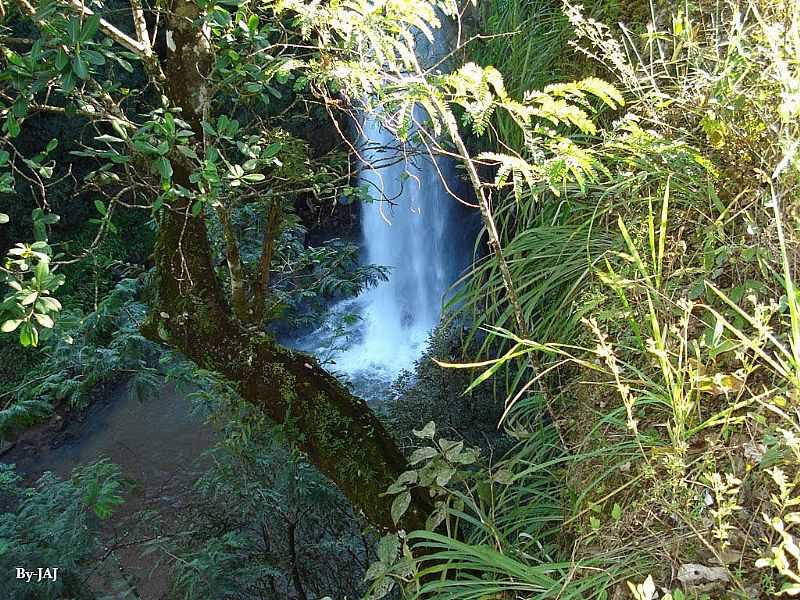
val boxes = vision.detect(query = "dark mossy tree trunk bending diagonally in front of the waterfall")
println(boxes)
[143,0,428,529]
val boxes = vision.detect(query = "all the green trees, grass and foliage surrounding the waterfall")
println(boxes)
[0,0,800,600]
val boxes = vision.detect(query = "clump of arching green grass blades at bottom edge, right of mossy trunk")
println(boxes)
[400,406,647,600]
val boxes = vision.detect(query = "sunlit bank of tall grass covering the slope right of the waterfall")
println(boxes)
[418,0,800,598]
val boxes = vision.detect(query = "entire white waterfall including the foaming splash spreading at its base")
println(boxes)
[298,18,474,399]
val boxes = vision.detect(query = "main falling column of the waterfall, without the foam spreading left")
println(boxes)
[336,115,459,379]
